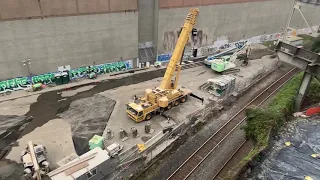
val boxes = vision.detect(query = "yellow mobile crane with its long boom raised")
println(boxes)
[126,8,199,122]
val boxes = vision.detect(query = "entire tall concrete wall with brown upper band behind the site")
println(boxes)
[0,0,320,80]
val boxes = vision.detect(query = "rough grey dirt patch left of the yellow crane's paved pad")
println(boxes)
[58,94,116,155]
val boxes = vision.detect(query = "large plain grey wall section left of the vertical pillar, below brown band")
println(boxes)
[0,11,138,79]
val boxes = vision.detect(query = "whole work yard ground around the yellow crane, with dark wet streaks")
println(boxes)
[0,45,278,179]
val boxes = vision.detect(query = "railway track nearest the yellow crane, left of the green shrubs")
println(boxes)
[167,68,300,180]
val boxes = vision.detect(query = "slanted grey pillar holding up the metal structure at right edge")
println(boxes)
[295,72,312,111]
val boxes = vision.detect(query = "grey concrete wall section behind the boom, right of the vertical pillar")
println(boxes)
[157,0,320,54]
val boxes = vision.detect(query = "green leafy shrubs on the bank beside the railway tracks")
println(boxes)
[244,73,302,147]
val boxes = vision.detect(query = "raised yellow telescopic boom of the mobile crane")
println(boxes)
[159,8,199,90]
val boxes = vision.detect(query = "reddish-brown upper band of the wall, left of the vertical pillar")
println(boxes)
[0,0,138,21]
